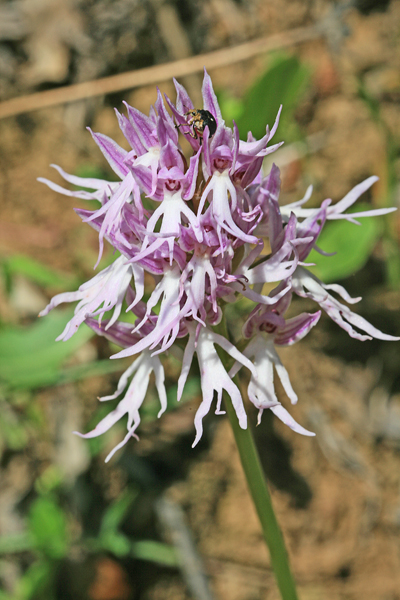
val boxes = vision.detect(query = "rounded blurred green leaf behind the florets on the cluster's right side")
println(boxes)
[307,204,382,283]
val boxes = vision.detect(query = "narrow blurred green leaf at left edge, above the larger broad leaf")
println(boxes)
[3,255,79,288]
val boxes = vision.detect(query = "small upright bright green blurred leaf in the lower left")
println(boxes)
[28,496,68,559]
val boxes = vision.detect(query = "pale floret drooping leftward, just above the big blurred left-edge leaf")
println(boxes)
[39,256,144,342]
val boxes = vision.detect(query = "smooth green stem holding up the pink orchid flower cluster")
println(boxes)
[224,395,298,600]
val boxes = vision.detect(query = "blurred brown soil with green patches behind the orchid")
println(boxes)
[0,0,400,600]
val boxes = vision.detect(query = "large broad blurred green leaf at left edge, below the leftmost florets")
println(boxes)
[0,310,94,389]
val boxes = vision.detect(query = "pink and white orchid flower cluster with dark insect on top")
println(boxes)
[40,72,398,460]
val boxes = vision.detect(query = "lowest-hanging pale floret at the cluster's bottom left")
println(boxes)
[74,351,167,462]
